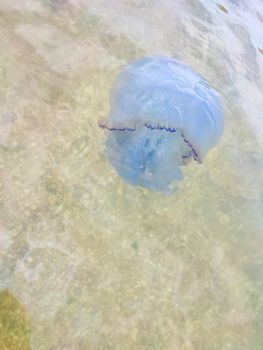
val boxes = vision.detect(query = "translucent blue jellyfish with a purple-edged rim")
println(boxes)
[99,56,224,192]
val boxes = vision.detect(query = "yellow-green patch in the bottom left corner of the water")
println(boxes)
[0,291,31,350]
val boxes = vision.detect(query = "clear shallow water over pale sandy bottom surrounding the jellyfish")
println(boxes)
[0,0,263,350]
